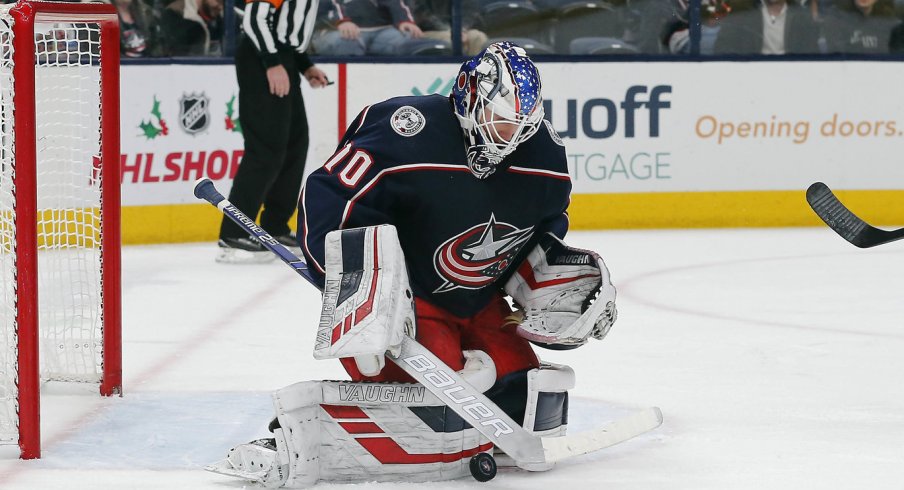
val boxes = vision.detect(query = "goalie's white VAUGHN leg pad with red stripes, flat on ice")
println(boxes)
[207,351,496,487]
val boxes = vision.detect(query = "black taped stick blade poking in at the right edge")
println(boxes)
[807,182,904,248]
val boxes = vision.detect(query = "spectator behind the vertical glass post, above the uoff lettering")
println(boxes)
[662,0,731,54]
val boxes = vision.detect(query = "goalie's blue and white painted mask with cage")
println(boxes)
[452,42,543,179]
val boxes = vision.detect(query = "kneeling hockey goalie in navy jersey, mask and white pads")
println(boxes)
[209,42,648,487]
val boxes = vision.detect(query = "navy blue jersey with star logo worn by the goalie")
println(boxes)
[298,95,571,317]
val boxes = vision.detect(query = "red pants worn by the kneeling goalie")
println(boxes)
[341,296,540,383]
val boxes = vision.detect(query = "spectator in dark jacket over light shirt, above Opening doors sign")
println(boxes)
[715,0,819,55]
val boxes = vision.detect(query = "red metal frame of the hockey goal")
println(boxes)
[10,2,122,459]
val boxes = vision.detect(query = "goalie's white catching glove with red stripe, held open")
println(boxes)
[505,233,617,349]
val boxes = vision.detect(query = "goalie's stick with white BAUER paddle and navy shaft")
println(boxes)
[194,178,662,470]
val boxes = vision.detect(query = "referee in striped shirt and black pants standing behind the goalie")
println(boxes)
[216,0,328,263]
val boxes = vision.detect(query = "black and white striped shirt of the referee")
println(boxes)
[242,0,319,66]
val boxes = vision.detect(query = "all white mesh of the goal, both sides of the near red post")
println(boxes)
[0,7,103,448]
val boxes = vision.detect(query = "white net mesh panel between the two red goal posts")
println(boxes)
[35,23,103,381]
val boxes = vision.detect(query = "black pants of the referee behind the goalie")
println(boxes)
[220,36,308,238]
